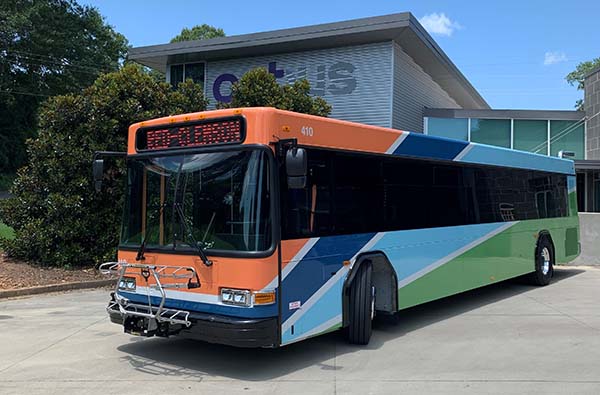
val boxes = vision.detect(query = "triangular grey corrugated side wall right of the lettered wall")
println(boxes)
[392,43,460,132]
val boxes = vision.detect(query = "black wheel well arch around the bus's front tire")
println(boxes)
[342,251,398,326]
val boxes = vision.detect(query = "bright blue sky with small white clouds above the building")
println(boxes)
[79,0,600,110]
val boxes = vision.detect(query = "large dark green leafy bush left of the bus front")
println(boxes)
[0,64,207,266]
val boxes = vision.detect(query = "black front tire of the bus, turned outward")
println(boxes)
[346,262,374,345]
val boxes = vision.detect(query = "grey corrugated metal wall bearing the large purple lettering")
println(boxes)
[206,41,393,127]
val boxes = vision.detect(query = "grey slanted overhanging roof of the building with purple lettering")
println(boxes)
[129,12,490,109]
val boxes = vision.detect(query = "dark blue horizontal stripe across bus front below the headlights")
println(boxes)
[119,291,277,318]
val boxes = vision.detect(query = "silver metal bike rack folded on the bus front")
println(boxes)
[99,262,200,333]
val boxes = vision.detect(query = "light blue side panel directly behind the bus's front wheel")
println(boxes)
[372,222,506,281]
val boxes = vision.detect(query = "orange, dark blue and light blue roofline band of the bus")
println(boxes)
[128,107,575,175]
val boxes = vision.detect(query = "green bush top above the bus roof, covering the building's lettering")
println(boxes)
[229,67,331,117]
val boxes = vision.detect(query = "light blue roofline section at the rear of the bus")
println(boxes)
[459,143,575,174]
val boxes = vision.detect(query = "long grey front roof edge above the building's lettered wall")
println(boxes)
[129,12,412,60]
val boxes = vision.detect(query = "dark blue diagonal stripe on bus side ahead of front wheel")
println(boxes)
[281,233,375,322]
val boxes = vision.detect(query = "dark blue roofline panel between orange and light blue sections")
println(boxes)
[394,133,469,160]
